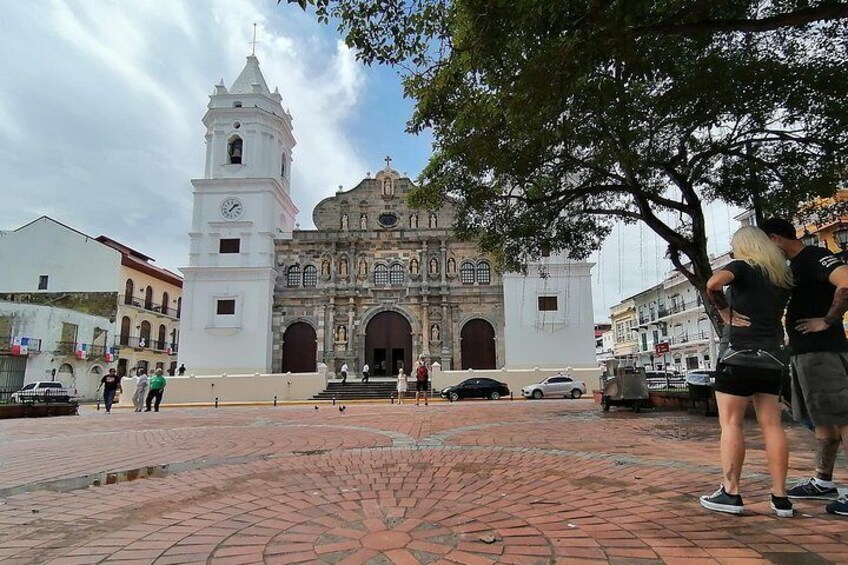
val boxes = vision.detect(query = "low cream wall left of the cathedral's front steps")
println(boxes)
[121,368,327,406]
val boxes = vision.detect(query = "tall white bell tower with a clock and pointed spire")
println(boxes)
[178,55,297,375]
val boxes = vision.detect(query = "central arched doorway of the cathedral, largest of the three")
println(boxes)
[365,312,412,377]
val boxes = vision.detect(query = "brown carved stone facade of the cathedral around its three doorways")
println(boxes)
[272,166,504,373]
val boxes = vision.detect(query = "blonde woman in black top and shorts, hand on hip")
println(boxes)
[701,227,793,518]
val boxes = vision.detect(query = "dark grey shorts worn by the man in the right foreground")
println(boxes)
[789,351,848,426]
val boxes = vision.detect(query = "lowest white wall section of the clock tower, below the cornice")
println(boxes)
[177,268,276,375]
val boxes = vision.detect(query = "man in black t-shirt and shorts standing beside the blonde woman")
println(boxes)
[760,218,848,516]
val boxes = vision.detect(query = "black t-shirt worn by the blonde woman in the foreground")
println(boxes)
[722,261,789,350]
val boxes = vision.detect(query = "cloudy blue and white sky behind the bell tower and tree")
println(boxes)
[0,0,736,321]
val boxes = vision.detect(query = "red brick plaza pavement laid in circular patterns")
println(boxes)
[0,400,848,565]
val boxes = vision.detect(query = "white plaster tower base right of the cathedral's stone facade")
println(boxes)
[503,258,597,369]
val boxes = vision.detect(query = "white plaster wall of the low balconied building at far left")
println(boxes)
[0,301,114,399]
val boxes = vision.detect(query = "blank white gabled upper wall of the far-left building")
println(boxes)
[0,217,121,292]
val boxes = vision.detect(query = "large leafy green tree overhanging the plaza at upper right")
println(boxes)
[289,0,848,327]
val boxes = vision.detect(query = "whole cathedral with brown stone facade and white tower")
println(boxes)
[179,55,595,376]
